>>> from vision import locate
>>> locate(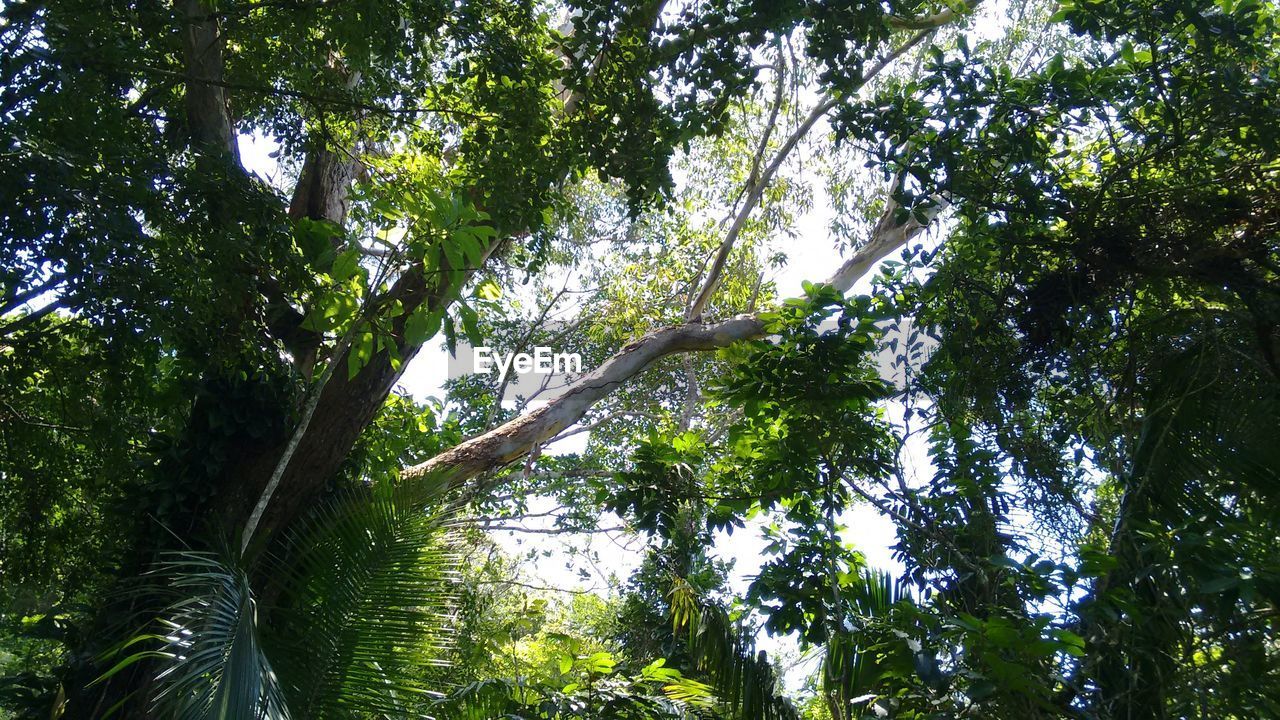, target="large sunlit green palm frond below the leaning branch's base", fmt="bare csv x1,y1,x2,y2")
273,476,458,716
